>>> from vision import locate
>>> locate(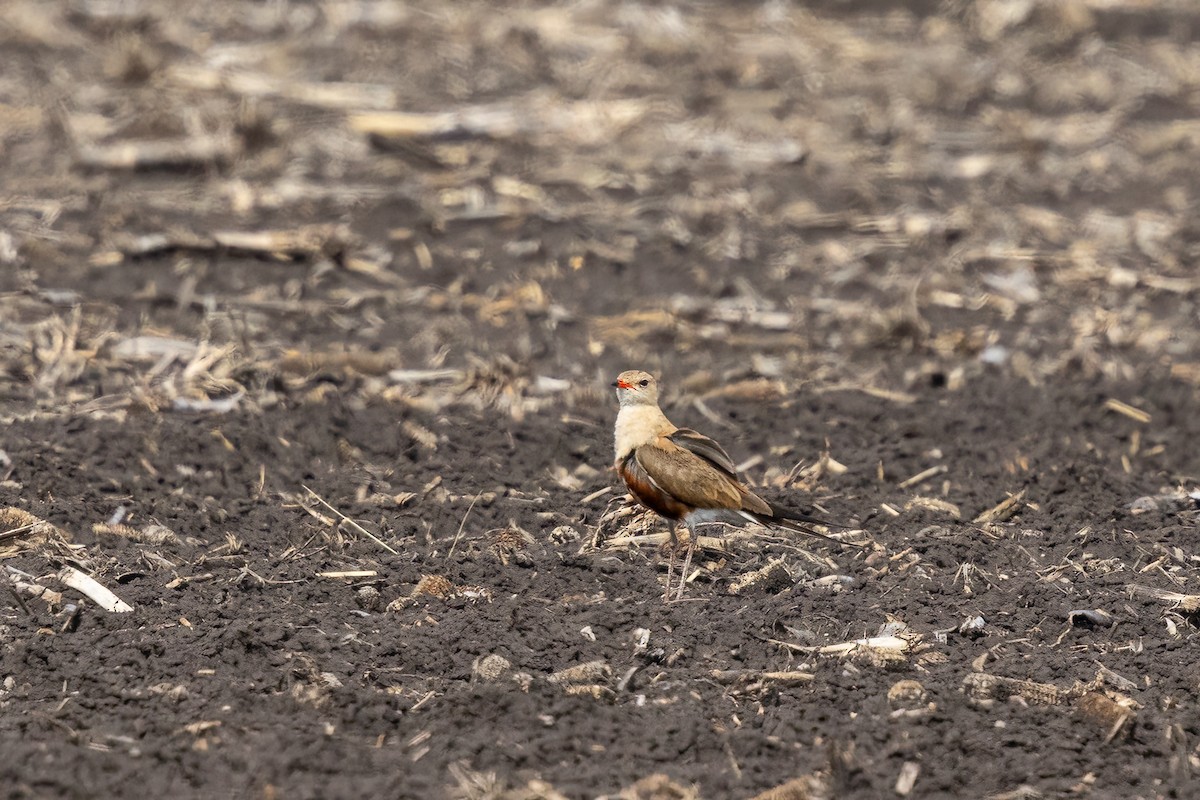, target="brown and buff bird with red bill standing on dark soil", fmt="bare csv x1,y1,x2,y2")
612,369,857,601
